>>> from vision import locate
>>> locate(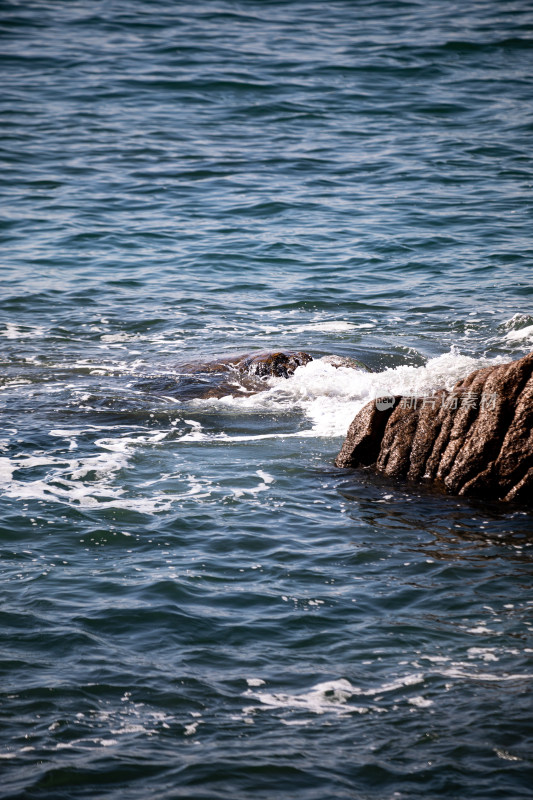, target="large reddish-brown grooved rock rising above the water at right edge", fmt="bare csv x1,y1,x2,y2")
335,353,533,504
